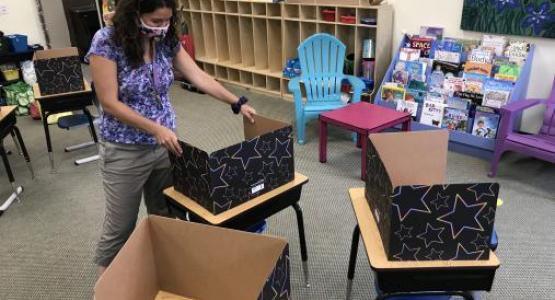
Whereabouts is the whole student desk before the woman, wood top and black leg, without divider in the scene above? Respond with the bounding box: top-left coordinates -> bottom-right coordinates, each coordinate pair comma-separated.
164,173 -> 310,287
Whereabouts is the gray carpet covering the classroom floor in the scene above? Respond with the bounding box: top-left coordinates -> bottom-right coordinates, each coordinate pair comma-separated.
0,87 -> 555,300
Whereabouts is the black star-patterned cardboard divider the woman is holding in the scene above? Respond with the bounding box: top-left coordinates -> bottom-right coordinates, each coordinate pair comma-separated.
170,115 -> 295,214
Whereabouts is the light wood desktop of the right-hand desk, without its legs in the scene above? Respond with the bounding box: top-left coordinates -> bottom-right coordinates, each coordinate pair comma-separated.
349,188 -> 500,271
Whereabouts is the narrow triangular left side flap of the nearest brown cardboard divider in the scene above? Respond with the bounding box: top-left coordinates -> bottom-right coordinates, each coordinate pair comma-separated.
95,219 -> 159,300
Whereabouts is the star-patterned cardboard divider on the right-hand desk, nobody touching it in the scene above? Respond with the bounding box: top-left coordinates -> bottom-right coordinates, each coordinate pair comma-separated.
366,130 -> 499,260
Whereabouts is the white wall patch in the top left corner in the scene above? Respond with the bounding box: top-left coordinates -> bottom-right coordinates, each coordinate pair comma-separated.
0,0 -> 45,45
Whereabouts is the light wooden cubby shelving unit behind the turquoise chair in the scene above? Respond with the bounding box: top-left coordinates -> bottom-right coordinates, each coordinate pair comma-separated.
179,0 -> 393,99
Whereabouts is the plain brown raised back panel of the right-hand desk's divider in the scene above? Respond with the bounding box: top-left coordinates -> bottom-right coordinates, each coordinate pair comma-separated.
370,130 -> 449,187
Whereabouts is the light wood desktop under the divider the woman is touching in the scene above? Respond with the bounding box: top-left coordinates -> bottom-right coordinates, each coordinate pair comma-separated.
164,173 -> 308,225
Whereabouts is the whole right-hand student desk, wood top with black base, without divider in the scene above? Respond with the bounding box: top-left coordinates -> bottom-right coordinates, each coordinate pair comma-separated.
347,188 -> 500,299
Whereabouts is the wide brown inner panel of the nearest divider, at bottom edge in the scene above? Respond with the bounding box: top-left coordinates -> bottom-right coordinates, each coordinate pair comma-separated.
149,216 -> 287,300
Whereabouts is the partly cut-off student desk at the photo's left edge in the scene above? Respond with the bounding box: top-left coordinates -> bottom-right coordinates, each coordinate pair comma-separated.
0,105 -> 35,215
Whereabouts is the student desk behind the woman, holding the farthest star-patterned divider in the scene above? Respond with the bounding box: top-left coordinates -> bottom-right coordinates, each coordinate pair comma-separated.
33,81 -> 98,171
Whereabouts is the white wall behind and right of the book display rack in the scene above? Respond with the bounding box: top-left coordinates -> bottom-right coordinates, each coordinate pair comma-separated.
388,0 -> 555,132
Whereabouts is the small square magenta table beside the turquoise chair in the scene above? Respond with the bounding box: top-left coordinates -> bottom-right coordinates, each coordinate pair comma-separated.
320,102 -> 412,180
